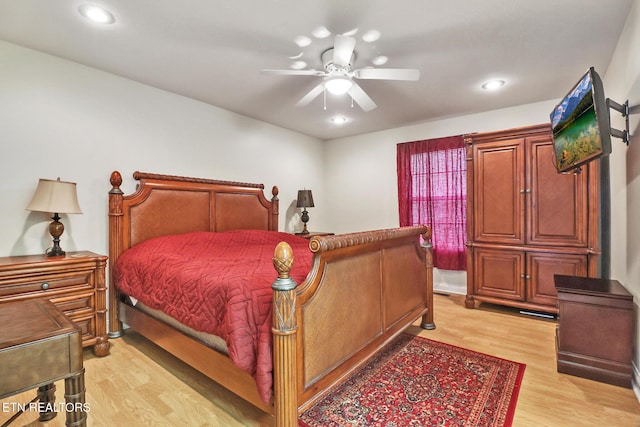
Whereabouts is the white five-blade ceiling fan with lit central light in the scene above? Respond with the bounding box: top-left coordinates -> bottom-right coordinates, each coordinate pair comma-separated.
262,34 -> 420,111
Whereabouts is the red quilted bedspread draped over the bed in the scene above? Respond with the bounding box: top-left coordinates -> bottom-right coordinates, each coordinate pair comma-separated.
114,230 -> 312,402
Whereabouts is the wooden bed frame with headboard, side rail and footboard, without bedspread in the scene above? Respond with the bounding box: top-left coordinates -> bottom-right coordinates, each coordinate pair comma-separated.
109,171 -> 435,426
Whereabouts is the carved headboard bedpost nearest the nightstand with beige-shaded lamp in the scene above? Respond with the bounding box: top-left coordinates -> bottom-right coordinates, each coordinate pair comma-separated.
107,171 -> 124,338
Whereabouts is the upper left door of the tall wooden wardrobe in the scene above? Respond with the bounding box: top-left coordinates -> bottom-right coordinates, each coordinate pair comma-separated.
473,138 -> 525,244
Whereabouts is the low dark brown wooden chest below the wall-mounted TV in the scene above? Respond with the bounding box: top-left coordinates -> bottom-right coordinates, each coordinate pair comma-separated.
554,275 -> 633,388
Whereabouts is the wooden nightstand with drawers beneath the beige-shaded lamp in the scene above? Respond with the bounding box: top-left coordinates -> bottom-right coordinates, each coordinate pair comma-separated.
0,251 -> 109,356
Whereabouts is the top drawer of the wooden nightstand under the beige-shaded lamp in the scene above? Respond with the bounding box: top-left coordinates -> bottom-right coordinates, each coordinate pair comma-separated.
0,271 -> 94,300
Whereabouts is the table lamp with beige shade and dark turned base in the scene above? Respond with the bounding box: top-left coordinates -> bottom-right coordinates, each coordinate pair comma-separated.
27,178 -> 82,256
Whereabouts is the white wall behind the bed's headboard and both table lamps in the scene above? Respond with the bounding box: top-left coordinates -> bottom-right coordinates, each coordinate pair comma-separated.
0,41 -> 328,256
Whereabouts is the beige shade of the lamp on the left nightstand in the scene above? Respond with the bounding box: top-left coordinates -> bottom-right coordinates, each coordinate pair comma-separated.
27,178 -> 82,214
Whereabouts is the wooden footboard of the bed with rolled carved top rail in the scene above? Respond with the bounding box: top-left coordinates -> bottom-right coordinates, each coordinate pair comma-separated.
273,227 -> 435,426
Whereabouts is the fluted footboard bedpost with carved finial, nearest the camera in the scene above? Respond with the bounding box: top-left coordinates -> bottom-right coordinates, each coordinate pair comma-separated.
271,242 -> 298,427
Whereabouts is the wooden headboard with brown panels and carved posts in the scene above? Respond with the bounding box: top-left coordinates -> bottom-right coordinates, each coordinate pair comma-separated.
109,171 -> 279,331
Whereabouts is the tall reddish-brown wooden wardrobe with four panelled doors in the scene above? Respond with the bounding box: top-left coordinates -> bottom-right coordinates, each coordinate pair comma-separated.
465,124 -> 600,313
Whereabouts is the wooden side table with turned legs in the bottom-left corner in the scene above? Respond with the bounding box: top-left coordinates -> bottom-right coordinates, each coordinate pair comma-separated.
0,299 -> 88,426
